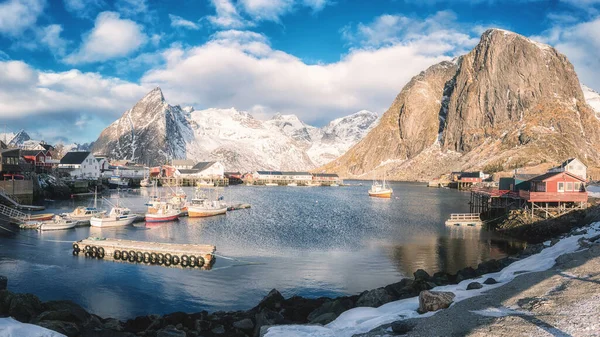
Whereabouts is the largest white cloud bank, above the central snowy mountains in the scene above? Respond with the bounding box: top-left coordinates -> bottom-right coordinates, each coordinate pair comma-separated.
142,25 -> 454,122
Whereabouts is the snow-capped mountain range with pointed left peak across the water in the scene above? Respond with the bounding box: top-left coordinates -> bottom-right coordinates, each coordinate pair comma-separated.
92,88 -> 377,171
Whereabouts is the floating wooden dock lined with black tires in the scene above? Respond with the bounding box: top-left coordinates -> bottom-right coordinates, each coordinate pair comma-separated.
73,237 -> 216,270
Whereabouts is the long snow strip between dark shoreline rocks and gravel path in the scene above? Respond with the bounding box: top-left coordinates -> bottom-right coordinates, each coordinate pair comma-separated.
265,222 -> 600,337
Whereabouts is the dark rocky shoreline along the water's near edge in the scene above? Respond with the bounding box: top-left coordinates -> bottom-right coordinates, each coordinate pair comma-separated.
0,239 -> 544,337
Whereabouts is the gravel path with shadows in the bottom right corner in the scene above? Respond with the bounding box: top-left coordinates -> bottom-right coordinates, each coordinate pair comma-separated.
400,244 -> 600,337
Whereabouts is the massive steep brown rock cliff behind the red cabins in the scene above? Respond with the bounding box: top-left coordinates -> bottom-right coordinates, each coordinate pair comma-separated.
322,29 -> 600,180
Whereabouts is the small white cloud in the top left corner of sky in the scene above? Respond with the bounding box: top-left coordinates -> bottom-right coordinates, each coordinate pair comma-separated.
0,0 -> 46,37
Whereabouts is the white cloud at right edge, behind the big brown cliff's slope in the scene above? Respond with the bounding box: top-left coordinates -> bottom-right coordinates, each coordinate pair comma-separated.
532,17 -> 600,91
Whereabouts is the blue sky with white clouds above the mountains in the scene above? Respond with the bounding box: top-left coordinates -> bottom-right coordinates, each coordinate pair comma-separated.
0,0 -> 600,143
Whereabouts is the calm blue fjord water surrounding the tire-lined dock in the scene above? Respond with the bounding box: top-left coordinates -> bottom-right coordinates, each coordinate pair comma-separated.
0,182 -> 522,319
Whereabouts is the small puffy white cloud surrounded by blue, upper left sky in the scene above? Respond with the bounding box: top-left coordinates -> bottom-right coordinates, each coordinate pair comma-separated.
65,12 -> 148,64
